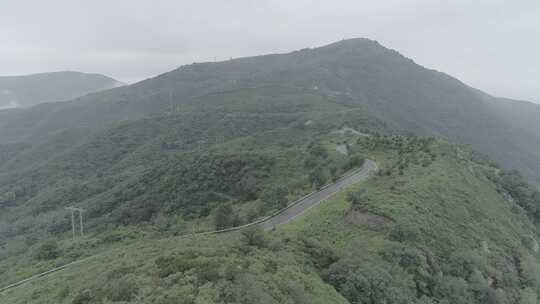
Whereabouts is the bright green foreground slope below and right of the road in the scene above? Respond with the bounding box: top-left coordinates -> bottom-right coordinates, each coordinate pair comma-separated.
0,135 -> 540,303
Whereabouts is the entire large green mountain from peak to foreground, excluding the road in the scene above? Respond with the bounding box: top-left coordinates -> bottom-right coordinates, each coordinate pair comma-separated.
0,39 -> 540,304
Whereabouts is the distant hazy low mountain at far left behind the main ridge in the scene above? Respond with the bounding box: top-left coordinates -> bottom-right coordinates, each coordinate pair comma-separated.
0,72 -> 124,110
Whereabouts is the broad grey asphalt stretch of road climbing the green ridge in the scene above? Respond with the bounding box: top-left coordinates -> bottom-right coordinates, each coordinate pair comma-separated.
259,159 -> 378,230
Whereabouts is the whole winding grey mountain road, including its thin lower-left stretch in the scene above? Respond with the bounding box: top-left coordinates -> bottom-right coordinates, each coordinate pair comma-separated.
0,159 -> 378,294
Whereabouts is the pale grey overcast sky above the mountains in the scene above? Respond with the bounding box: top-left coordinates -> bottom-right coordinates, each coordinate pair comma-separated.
0,0 -> 540,102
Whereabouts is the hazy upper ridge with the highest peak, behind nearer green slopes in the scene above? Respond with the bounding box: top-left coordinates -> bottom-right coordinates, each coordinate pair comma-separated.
0,39 -> 540,182
